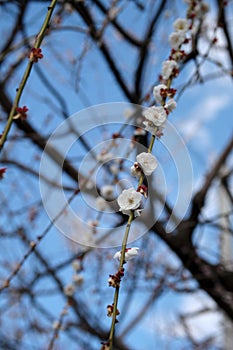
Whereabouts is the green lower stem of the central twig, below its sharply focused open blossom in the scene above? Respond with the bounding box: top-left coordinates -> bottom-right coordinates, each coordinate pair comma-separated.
109,211 -> 134,350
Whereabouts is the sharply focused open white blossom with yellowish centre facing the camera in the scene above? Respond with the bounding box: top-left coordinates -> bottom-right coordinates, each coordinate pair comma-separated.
117,187 -> 142,215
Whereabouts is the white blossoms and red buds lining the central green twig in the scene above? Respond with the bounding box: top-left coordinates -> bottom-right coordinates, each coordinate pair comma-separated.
101,0 -> 209,350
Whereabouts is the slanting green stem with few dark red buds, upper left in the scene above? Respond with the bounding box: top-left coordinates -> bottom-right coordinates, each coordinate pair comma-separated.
0,0 -> 57,152
